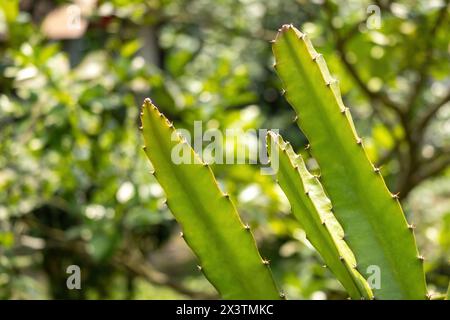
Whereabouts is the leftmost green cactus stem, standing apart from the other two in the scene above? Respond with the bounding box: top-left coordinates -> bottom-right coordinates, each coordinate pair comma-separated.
141,99 -> 280,299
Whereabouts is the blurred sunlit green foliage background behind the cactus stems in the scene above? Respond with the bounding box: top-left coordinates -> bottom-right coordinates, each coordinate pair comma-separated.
0,0 -> 450,299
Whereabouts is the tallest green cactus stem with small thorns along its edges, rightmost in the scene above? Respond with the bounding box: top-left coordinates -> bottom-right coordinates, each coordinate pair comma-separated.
273,25 -> 426,299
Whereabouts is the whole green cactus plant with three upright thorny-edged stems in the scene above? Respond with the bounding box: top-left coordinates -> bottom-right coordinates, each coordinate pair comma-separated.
141,25 -> 429,299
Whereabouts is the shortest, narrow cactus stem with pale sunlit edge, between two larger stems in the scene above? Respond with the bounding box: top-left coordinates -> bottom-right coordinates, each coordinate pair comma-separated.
267,132 -> 373,299
